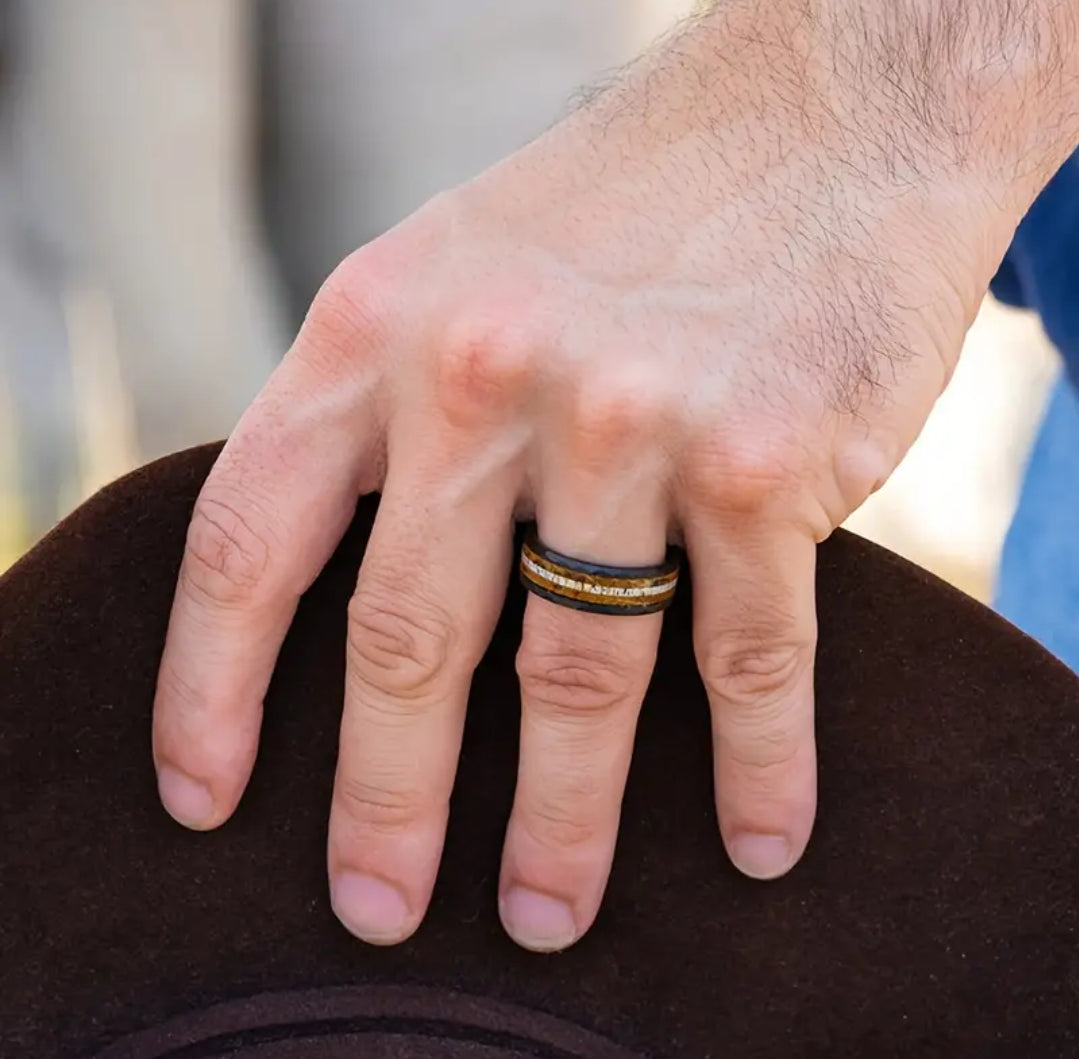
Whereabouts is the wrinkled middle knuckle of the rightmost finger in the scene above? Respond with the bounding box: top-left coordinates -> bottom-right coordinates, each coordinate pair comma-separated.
701,637 -> 812,712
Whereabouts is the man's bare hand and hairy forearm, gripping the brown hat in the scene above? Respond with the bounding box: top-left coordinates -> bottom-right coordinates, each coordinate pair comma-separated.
153,0 -> 1079,950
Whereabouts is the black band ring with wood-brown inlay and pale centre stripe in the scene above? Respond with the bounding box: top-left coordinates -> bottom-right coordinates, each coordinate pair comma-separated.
520,530 -> 679,614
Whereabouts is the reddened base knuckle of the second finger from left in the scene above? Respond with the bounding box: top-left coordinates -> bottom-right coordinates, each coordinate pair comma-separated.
435,310 -> 537,422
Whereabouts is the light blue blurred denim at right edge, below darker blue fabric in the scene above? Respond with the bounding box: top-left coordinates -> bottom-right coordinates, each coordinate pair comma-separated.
995,378 -> 1079,671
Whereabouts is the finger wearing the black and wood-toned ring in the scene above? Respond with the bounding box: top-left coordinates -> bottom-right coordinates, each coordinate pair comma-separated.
500,395 -> 667,951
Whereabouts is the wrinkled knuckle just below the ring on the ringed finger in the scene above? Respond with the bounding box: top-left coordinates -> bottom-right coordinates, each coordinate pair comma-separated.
517,642 -> 632,717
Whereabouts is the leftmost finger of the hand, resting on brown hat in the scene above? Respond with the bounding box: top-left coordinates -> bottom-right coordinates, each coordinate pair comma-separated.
153,278 -> 388,830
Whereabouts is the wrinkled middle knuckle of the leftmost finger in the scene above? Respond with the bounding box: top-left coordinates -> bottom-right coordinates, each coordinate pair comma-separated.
182,495 -> 272,603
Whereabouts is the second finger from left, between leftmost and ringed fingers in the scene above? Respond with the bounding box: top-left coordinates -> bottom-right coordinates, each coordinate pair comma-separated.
328,405 -> 518,945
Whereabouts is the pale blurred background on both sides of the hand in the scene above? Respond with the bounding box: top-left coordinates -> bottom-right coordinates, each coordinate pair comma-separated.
0,0 -> 1057,599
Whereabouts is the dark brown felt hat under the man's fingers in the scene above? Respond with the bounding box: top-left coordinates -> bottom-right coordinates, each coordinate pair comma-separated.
0,440 -> 1079,1059
